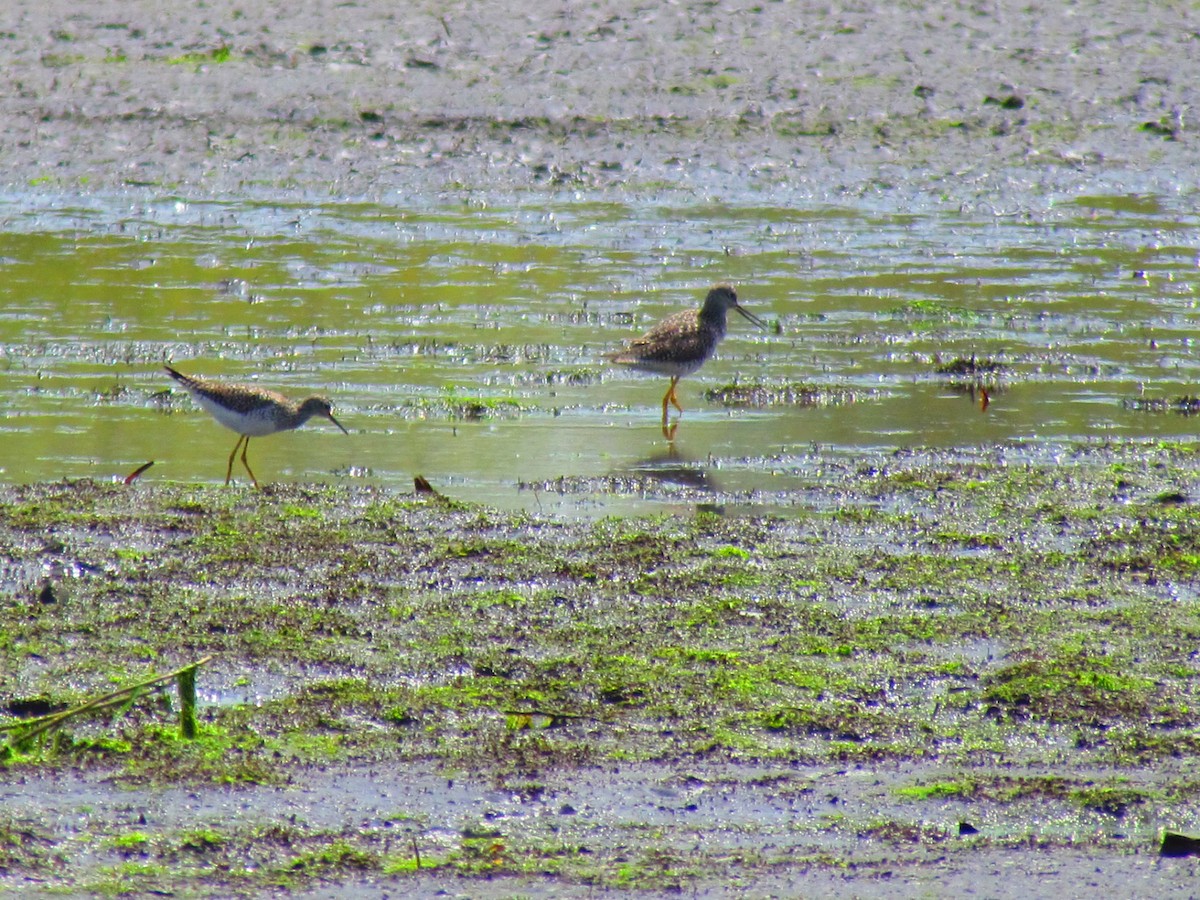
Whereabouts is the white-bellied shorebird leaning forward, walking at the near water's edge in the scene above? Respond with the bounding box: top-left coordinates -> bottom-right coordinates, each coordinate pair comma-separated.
163,366 -> 350,487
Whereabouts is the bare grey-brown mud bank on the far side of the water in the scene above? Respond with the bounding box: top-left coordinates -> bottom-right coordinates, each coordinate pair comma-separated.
0,0 -> 1200,200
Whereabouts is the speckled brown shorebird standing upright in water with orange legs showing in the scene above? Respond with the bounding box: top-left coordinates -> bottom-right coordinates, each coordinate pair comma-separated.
606,284 -> 767,428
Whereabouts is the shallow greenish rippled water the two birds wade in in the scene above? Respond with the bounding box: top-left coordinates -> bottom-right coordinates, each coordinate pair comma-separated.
0,193 -> 1200,515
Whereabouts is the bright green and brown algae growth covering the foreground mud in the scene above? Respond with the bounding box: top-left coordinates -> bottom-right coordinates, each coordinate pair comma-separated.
0,445 -> 1200,893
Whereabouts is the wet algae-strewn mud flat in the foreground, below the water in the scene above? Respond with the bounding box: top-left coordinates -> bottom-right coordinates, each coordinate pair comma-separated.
0,444 -> 1200,896
